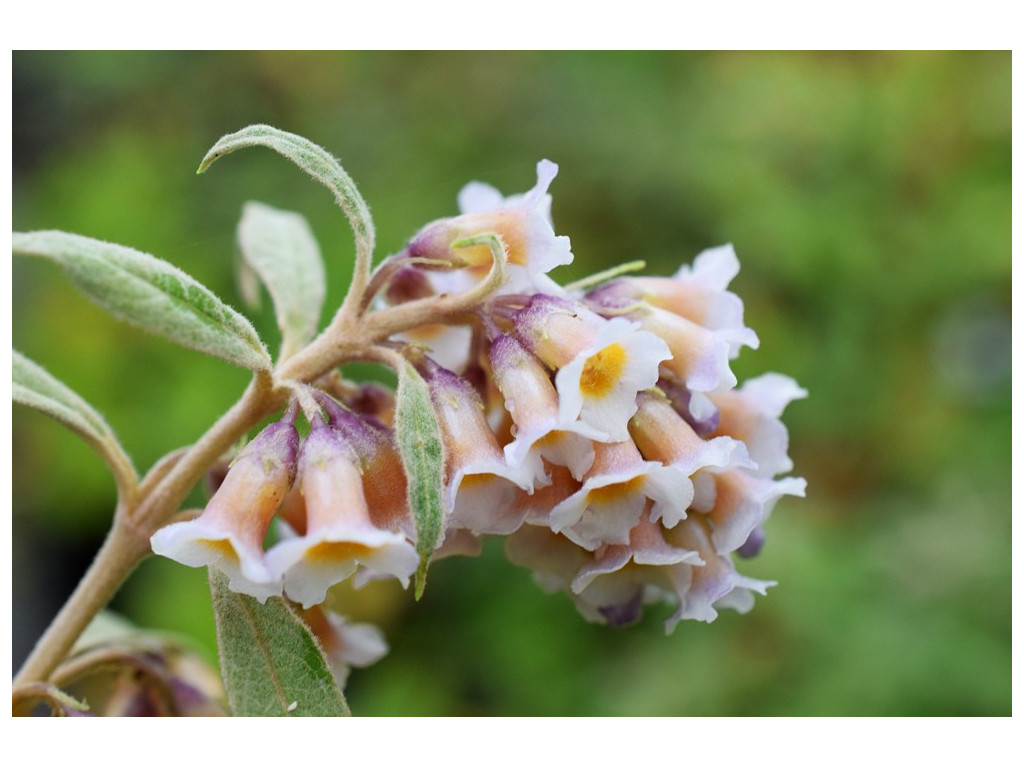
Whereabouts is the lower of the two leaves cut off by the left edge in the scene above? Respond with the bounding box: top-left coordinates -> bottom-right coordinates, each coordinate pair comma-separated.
11,349 -> 138,492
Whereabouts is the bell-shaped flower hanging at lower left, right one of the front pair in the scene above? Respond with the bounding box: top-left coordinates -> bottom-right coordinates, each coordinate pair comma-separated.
266,419 -> 419,608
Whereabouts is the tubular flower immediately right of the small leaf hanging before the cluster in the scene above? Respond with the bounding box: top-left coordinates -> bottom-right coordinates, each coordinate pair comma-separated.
426,366 -> 534,535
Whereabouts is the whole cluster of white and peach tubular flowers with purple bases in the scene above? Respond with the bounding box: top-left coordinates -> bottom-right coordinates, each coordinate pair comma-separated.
153,161 -> 806,662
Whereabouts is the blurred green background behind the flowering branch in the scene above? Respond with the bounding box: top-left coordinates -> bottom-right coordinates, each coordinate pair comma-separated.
12,52 -> 1011,715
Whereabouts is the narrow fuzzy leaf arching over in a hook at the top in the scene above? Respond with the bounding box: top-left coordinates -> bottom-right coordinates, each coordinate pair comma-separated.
197,125 -> 375,282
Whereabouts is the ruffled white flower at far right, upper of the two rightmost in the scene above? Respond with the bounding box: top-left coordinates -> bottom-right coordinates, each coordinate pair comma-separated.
711,374 -> 807,477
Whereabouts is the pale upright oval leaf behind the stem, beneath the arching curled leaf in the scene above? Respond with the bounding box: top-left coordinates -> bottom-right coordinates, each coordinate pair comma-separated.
238,202 -> 326,359
